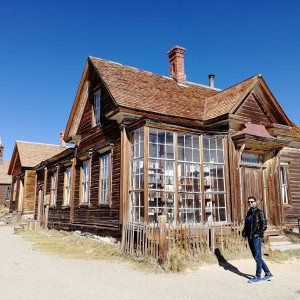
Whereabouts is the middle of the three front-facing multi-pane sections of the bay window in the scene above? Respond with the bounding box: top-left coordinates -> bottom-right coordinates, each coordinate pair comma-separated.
177,133 -> 202,223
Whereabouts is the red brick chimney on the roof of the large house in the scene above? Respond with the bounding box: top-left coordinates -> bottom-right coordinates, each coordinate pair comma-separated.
168,46 -> 186,83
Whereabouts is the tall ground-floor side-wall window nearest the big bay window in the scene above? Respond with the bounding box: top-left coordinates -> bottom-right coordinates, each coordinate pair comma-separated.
98,152 -> 112,206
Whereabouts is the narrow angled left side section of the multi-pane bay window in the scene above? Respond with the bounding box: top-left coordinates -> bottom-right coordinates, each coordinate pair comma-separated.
130,128 -> 144,222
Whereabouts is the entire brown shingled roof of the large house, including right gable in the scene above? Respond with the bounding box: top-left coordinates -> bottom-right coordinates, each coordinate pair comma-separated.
65,57 -> 292,140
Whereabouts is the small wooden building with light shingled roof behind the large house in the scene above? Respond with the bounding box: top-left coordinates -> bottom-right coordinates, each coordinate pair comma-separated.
8,141 -> 66,218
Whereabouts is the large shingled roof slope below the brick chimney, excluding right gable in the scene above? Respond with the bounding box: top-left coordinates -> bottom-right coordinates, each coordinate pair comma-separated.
89,57 -> 219,120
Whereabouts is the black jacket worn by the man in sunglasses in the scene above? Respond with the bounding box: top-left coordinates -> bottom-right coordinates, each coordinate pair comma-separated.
242,207 -> 267,239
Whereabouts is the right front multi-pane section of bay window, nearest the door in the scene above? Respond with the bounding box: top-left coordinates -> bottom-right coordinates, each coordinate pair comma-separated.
203,136 -> 227,222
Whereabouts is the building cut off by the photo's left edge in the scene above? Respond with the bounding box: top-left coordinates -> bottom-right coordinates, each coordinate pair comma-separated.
0,138 -> 11,208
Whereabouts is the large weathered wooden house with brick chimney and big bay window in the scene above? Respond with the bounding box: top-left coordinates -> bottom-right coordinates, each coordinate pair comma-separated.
29,46 -> 300,235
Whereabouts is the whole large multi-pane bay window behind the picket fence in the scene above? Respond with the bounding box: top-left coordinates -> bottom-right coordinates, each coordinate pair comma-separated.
130,128 -> 227,223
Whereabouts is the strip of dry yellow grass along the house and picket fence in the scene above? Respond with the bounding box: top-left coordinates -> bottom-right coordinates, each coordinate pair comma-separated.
22,230 -> 300,273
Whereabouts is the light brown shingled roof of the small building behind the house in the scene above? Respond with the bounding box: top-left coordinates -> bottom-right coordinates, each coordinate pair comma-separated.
8,141 -> 66,174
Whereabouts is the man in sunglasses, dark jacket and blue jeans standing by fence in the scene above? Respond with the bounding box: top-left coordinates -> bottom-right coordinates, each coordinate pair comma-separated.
242,196 -> 273,283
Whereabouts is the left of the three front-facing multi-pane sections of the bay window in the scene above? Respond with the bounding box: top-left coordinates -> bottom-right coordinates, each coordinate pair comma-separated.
148,128 -> 175,222
